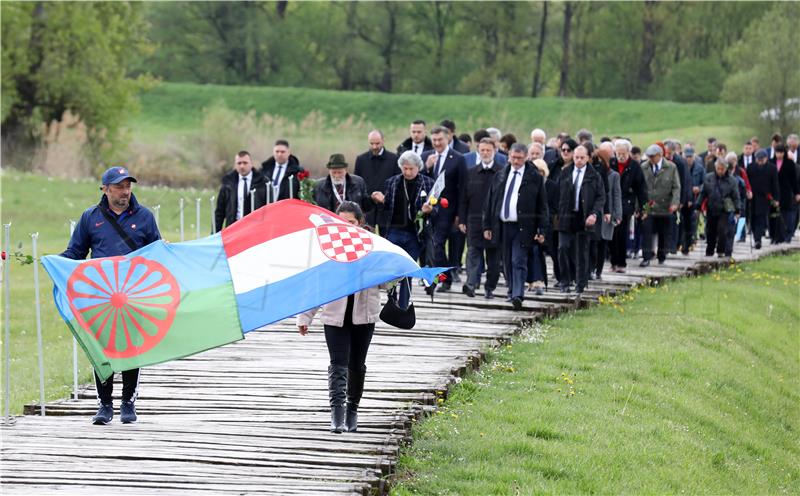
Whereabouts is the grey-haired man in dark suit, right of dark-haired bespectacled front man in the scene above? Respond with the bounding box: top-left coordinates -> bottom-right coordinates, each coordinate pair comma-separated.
557,145 -> 606,293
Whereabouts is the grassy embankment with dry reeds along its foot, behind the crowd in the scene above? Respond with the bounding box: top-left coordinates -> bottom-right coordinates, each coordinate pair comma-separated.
129,83 -> 751,183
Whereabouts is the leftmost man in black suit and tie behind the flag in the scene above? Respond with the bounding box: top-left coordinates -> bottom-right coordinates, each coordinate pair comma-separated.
214,151 -> 267,232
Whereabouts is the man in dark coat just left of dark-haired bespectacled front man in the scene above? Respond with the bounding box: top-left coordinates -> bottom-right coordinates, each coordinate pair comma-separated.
458,136 -> 503,300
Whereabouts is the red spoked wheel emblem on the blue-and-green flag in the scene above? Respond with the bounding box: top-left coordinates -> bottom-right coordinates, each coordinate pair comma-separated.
67,257 -> 181,358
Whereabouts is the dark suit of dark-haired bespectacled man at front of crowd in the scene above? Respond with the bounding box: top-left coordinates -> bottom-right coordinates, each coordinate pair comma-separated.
483,166 -> 550,300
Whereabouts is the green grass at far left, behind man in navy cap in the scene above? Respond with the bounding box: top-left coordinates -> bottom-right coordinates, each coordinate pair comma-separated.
0,170 -> 212,414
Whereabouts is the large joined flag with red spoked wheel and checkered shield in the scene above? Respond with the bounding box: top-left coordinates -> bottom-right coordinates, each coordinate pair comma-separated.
42,200 -> 444,379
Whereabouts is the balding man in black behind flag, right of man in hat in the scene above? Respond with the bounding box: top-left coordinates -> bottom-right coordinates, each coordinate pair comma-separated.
354,129 -> 400,228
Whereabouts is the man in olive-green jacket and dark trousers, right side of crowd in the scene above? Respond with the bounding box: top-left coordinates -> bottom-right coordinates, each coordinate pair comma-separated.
639,145 -> 681,267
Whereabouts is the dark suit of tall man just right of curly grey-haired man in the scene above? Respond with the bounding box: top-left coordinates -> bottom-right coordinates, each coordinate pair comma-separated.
421,148 -> 467,287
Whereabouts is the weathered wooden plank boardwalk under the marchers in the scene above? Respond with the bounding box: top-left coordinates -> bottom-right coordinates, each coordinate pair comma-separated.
0,240 -> 800,495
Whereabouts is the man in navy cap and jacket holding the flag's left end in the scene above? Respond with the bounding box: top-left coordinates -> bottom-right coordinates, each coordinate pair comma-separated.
61,166 -> 161,425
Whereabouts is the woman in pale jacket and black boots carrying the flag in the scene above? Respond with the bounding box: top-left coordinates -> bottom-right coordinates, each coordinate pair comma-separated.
297,201 -> 380,434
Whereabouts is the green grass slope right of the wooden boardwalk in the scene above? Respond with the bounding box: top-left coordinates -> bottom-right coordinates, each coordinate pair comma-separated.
393,254 -> 800,495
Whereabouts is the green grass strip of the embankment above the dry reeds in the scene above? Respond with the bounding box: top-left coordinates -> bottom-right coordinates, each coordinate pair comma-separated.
131,83 -> 748,144
